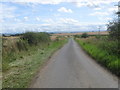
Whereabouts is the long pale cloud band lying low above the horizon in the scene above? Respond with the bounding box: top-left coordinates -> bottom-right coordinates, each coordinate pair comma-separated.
2,18 -> 105,33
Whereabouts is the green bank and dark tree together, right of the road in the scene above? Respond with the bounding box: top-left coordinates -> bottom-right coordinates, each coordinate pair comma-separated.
75,21 -> 120,77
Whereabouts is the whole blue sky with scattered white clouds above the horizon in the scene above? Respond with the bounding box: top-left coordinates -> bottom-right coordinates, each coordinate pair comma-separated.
0,0 -> 119,33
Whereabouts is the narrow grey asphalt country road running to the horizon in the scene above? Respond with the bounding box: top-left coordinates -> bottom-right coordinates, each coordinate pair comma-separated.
30,39 -> 118,88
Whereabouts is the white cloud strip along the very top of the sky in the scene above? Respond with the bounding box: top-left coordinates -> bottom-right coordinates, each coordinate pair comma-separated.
0,0 -> 119,8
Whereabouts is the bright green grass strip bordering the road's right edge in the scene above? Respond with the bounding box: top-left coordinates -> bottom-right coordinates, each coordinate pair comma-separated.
76,39 -> 120,76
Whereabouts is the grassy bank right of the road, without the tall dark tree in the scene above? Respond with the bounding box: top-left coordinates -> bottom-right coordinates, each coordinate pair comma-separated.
76,36 -> 120,76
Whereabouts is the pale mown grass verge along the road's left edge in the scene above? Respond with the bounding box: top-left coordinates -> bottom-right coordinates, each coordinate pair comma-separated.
3,40 -> 67,88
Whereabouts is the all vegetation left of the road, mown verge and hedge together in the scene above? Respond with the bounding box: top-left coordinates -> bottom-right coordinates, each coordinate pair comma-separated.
2,32 -> 67,88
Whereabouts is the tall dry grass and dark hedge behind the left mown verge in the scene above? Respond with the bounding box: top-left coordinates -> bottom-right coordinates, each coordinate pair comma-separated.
2,32 -> 50,71
